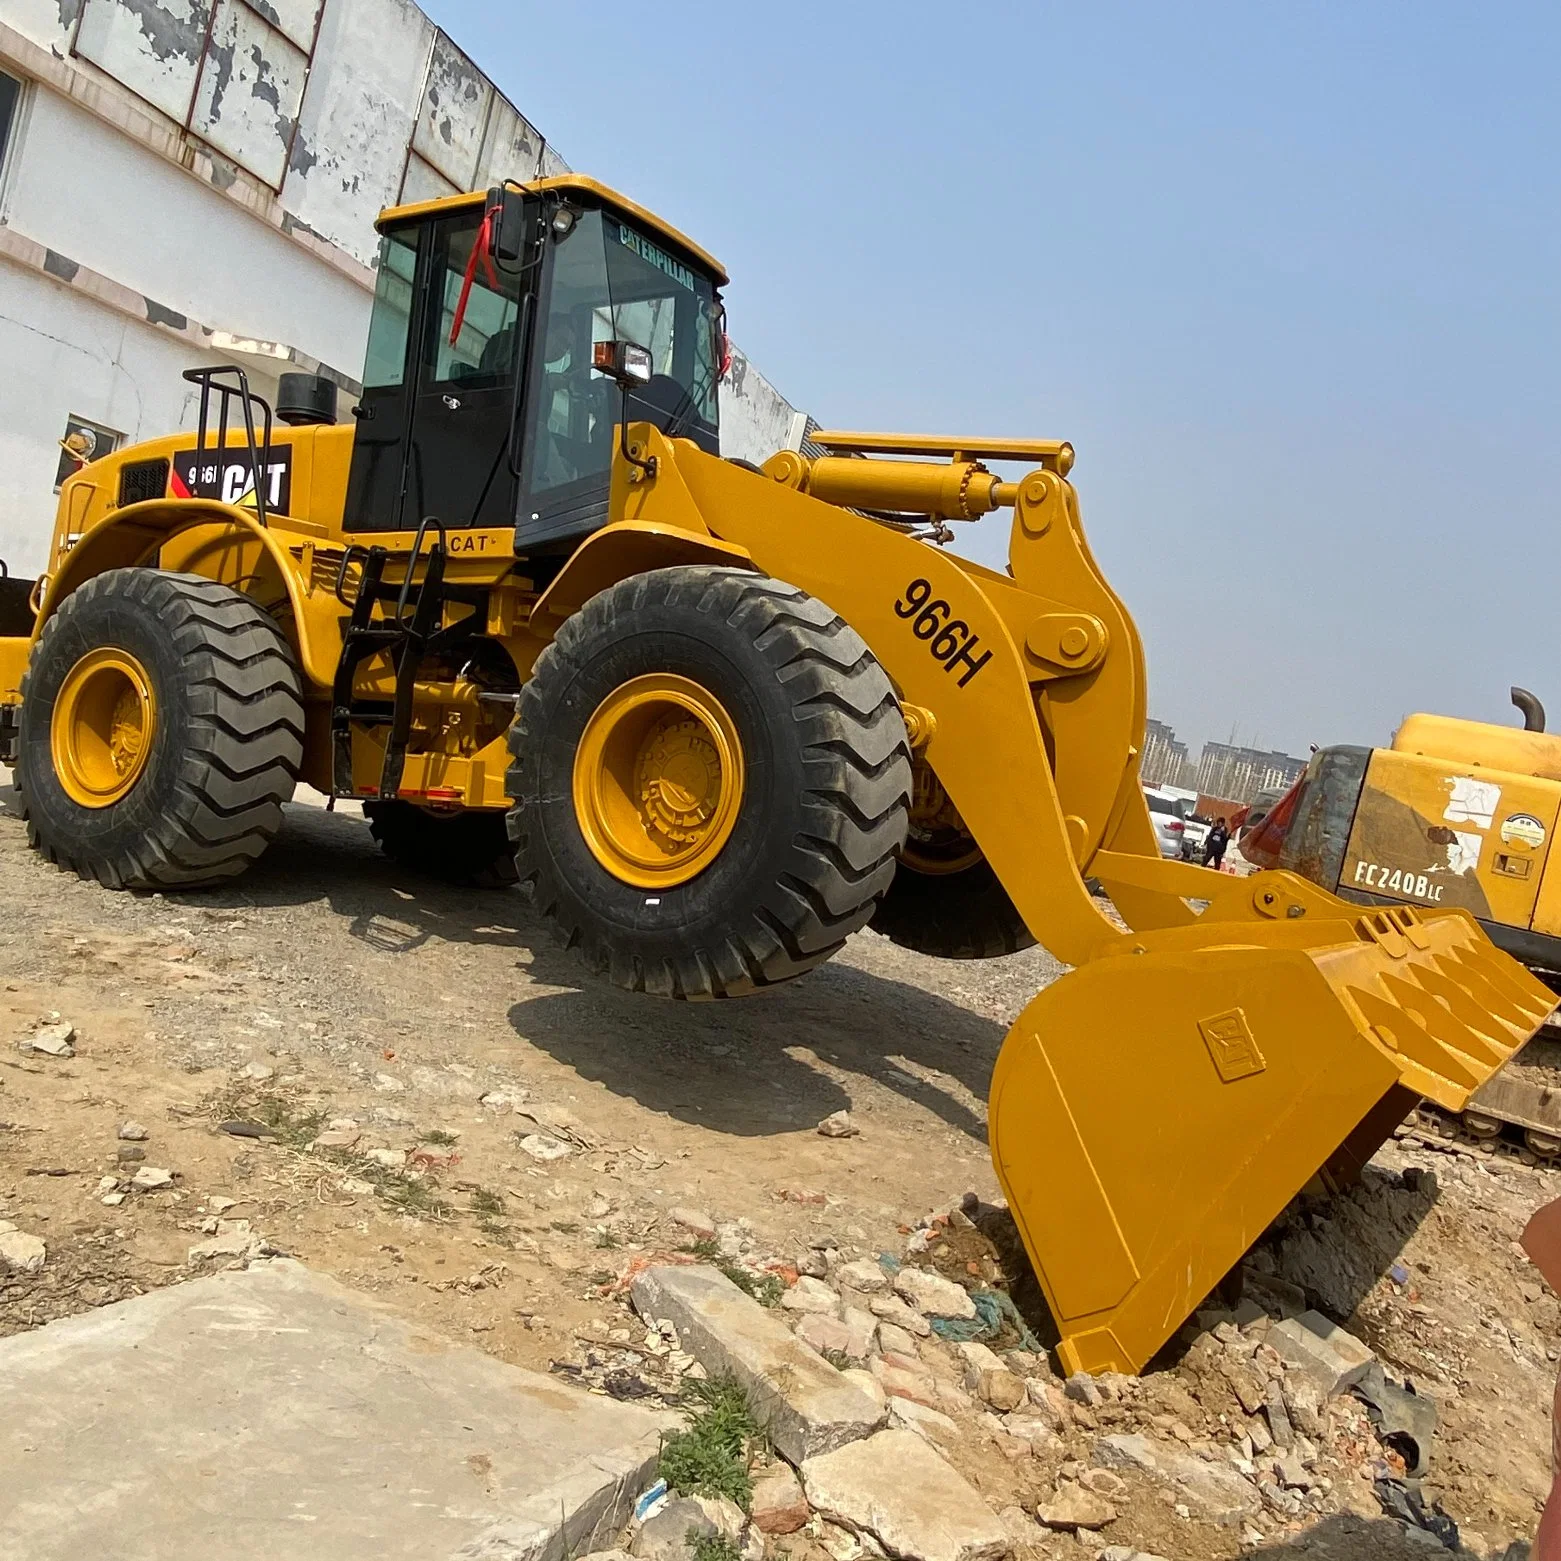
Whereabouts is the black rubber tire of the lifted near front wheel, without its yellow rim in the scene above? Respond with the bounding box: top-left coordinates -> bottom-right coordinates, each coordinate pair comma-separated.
509,567 -> 910,997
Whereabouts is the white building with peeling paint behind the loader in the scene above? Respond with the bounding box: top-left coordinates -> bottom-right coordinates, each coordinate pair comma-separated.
0,0 -> 802,574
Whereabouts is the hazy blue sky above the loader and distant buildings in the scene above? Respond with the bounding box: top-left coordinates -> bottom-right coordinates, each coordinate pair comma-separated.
425,0 -> 1561,752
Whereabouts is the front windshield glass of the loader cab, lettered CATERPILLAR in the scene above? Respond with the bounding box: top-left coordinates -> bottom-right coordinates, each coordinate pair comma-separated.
528,211 -> 720,495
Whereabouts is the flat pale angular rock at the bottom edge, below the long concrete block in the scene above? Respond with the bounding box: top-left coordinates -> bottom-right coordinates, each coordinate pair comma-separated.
802,1431 -> 1010,1561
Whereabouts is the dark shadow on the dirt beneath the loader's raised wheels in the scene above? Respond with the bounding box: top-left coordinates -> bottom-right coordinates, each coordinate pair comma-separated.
0,790 -> 1004,1146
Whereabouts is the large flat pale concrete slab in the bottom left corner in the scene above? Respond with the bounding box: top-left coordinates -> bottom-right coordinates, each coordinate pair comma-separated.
0,1260 -> 664,1561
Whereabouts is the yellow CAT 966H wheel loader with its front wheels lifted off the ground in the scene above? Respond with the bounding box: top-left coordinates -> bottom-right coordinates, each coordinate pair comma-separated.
0,176 -> 1550,1371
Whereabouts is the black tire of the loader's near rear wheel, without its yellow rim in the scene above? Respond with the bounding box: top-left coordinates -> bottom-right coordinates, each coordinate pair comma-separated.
16,570 -> 303,890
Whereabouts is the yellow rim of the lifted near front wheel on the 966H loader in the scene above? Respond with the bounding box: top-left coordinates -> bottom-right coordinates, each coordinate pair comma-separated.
574,673 -> 743,888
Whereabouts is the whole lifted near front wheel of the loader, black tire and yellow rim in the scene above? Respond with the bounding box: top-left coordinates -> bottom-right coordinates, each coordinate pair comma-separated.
509,567 -> 910,997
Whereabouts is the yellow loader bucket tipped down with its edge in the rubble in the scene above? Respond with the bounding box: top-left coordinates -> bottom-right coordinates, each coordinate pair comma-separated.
990,904 -> 1555,1372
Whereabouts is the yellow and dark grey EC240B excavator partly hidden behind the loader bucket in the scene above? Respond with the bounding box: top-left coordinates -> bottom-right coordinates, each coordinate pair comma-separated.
1241,688 -> 1561,1160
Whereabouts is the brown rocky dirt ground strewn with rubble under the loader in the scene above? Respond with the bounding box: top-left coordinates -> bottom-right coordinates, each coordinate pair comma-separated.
0,771 -> 1561,1561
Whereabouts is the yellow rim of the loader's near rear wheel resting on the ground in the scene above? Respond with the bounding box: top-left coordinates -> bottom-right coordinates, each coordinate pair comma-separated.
48,646 -> 158,807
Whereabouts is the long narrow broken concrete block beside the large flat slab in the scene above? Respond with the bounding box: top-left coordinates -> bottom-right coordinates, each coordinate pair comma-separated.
632,1264 -> 884,1464
